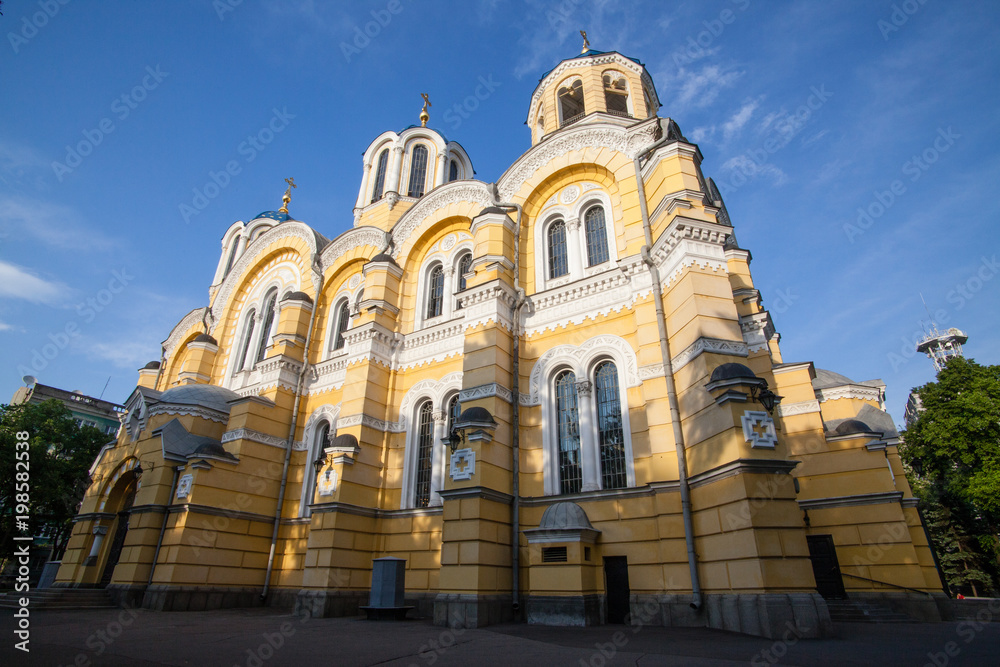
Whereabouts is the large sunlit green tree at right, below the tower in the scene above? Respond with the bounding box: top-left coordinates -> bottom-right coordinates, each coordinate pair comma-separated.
900,357 -> 1000,593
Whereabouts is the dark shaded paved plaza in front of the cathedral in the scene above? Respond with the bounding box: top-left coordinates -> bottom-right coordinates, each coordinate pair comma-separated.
0,609 -> 1000,667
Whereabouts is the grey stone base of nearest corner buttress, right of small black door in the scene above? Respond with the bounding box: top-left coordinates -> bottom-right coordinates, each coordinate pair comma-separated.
630,593 -> 833,639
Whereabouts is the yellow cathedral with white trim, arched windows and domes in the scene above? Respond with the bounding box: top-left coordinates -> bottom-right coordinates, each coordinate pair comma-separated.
56,45 -> 945,637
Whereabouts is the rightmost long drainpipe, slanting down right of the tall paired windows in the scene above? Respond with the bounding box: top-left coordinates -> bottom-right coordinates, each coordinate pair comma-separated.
633,124 -> 702,609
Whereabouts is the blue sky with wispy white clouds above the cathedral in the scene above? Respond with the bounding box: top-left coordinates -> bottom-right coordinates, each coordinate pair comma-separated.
0,0 -> 1000,422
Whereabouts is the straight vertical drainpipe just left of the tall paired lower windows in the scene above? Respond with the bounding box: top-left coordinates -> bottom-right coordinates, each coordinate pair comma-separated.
494,198 -> 527,614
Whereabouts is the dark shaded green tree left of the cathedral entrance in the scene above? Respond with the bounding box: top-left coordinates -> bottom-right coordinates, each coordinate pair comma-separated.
0,400 -> 108,572
